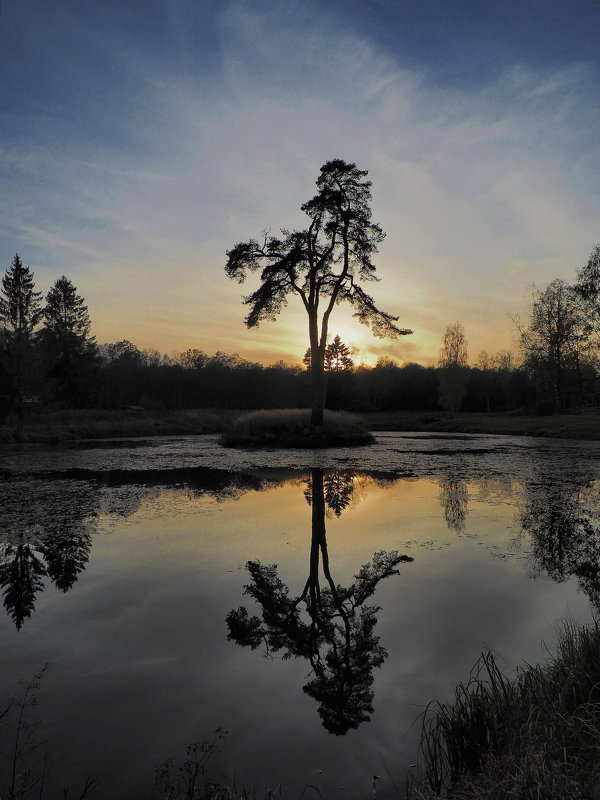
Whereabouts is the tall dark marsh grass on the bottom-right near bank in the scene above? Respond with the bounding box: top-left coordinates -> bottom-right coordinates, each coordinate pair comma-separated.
408,623 -> 600,800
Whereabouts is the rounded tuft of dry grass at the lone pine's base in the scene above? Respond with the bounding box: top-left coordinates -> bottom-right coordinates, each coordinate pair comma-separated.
220,408 -> 375,449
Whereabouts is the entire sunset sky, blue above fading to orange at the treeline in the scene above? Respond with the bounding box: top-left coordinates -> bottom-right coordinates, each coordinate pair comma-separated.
0,0 -> 600,363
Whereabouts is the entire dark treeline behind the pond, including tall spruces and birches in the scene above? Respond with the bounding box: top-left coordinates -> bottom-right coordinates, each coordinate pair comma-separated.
0,247 -> 600,419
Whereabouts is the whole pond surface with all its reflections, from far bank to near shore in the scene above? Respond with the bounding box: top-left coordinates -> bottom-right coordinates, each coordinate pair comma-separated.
0,433 -> 600,800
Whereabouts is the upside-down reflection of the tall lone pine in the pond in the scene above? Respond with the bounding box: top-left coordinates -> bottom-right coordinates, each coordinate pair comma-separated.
227,469 -> 413,734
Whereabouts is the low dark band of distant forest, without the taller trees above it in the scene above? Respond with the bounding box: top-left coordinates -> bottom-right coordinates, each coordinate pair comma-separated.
0,330 -> 576,412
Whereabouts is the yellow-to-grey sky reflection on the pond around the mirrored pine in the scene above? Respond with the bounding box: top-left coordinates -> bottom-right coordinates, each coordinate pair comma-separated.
0,468 -> 589,800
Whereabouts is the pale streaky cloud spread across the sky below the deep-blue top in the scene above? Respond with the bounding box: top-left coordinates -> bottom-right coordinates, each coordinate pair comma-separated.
0,2 -> 600,360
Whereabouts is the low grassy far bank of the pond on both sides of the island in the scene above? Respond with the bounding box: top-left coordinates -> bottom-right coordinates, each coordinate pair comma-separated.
0,409 -> 600,446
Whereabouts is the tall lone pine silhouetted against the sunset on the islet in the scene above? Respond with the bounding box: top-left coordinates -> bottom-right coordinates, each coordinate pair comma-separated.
225,158 -> 412,425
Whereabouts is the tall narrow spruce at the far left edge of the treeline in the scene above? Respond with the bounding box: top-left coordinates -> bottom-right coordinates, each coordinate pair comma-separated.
0,253 -> 41,424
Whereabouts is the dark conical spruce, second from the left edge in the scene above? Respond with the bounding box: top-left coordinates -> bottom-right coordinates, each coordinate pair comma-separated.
39,275 -> 97,408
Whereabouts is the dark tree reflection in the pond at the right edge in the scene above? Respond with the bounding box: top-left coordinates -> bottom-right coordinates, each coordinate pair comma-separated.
521,480 -> 600,611
